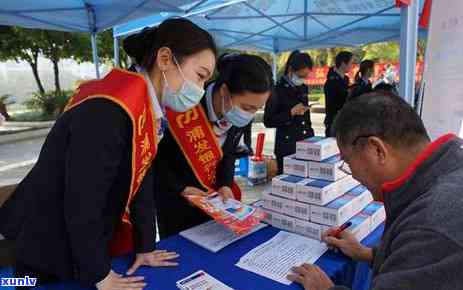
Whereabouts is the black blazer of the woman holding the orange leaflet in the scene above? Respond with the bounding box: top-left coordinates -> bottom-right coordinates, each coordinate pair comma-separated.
154,89 -> 246,195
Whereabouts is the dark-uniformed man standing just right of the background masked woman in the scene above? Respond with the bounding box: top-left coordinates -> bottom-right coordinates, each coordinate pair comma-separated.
323,51 -> 353,137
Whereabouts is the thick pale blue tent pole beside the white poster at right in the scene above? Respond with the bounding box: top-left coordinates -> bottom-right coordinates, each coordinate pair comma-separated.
399,0 -> 419,106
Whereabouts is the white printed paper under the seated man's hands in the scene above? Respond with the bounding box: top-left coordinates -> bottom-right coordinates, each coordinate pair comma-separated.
236,232 -> 328,285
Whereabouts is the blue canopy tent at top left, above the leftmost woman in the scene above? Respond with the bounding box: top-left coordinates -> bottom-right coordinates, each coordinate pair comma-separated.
0,0 -> 221,77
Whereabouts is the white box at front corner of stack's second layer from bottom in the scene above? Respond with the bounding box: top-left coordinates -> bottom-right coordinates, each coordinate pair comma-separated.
310,194 -> 355,226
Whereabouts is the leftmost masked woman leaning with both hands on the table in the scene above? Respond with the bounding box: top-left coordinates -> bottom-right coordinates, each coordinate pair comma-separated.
0,19 -> 216,290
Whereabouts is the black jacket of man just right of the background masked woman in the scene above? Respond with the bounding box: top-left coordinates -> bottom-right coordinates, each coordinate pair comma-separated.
323,68 -> 349,135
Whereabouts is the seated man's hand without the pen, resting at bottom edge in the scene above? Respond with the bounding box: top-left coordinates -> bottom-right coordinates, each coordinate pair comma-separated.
288,264 -> 334,290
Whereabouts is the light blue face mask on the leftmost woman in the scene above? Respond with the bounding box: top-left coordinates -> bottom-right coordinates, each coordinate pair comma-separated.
162,57 -> 204,112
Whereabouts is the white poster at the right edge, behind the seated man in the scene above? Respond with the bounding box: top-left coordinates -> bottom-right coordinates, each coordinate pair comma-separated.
421,0 -> 463,140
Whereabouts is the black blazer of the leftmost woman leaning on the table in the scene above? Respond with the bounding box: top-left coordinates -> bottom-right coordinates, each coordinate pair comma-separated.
0,99 -> 155,285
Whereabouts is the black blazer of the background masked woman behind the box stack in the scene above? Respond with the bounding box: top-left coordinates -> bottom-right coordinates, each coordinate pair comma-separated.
264,76 -> 314,156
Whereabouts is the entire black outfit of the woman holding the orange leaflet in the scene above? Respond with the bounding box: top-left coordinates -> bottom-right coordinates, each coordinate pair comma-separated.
154,90 -> 246,239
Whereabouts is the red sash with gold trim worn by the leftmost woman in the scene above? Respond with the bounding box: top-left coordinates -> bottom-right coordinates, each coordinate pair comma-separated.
65,69 -> 157,256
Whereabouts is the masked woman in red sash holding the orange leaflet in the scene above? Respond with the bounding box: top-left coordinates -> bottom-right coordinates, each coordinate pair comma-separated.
155,54 -> 272,239
